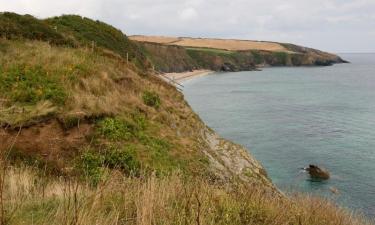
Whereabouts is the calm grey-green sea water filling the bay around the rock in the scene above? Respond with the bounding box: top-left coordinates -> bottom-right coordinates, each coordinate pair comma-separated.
184,54 -> 375,218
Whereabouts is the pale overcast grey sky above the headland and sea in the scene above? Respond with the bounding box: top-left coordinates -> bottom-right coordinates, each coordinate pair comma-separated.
0,0 -> 375,53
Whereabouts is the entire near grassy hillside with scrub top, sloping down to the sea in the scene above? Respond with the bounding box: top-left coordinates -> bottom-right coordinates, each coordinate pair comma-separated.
0,13 -> 365,225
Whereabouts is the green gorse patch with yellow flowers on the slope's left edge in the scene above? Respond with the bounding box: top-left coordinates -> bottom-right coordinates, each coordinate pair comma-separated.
0,64 -> 67,105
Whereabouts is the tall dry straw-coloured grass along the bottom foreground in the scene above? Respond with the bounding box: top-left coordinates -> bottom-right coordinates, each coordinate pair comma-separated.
0,167 -> 369,225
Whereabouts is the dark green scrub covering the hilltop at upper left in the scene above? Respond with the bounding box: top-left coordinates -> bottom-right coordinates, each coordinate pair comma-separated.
0,12 -> 148,70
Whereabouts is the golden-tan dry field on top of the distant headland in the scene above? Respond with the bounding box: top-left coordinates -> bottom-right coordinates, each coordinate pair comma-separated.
129,36 -> 289,52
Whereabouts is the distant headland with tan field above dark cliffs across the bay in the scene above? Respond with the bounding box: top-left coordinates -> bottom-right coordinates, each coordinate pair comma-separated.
129,35 -> 346,72
